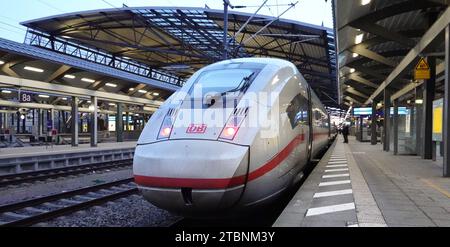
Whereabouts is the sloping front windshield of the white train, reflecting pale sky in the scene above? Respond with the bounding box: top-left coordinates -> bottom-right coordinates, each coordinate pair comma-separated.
191,69 -> 255,98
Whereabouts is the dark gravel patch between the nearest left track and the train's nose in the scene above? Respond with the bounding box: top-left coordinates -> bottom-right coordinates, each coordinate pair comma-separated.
35,195 -> 177,227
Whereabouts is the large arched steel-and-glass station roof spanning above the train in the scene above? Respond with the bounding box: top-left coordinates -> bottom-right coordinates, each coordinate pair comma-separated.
22,7 -> 338,106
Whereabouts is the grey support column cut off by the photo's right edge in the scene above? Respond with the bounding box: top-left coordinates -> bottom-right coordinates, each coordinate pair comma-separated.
442,26 -> 450,177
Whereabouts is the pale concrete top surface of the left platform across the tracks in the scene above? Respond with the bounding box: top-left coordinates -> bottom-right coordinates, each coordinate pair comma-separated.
0,141 -> 136,159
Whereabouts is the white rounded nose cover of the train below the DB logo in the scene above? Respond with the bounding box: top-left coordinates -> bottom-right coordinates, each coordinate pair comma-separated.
133,140 -> 249,214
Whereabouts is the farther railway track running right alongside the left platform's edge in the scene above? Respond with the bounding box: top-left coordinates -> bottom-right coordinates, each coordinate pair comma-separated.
0,159 -> 133,187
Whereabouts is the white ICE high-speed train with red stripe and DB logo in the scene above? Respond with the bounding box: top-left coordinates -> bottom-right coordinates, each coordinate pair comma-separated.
133,58 -> 330,215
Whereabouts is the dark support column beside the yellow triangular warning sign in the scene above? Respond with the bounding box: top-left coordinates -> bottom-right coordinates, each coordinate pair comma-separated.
422,57 -> 436,159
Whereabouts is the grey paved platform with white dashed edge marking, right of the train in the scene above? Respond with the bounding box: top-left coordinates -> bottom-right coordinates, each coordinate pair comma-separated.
274,136 -> 450,227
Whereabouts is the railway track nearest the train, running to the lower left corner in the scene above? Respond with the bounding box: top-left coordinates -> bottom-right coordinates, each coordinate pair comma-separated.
0,178 -> 138,226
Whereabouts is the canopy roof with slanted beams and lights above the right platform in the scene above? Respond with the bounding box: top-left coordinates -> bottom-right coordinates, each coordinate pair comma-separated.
334,0 -> 448,106
